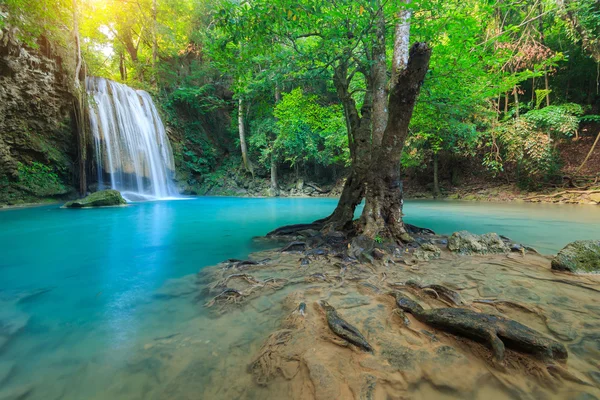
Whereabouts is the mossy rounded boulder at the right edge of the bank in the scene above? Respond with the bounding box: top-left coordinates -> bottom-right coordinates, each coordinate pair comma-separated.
552,240 -> 600,272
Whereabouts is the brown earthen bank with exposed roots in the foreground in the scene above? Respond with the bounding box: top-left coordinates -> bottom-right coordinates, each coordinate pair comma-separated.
150,235 -> 600,399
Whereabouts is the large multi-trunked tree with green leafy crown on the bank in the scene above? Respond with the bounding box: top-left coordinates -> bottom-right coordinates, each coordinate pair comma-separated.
217,0 -> 431,240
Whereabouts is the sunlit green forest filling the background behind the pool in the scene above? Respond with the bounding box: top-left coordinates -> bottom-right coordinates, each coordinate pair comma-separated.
0,0 -> 600,206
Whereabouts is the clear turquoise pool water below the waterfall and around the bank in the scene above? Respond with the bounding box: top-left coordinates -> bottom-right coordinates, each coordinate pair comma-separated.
0,198 -> 600,399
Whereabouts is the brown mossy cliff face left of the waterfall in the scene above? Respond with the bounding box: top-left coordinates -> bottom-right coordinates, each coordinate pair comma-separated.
0,27 -> 77,204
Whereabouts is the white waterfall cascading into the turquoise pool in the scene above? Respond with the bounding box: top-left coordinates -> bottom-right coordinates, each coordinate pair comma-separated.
86,77 -> 178,201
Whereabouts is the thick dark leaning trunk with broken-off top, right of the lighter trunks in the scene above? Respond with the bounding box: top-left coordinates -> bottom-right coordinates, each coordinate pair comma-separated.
360,43 -> 431,240
